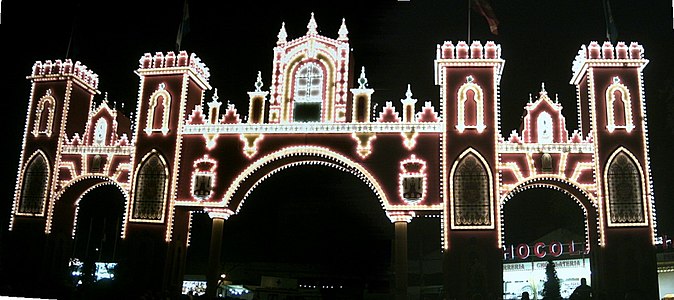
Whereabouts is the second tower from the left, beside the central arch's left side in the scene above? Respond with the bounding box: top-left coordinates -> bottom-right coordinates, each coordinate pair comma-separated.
123,51 -> 211,290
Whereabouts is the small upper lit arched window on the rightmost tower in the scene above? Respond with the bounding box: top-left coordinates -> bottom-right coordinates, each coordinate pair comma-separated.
606,77 -> 634,132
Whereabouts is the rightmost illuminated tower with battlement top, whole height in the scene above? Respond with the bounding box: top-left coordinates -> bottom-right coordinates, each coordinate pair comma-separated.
571,42 -> 658,298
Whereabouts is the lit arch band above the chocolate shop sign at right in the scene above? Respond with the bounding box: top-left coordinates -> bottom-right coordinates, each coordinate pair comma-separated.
498,176 -> 603,253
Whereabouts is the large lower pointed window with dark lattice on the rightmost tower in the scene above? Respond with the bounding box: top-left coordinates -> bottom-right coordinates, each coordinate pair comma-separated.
606,151 -> 645,223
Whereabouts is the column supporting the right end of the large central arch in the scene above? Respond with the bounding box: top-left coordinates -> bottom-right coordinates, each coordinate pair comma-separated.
386,211 -> 414,300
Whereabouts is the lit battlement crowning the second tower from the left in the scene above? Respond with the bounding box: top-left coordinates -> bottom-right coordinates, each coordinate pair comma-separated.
138,51 -> 211,83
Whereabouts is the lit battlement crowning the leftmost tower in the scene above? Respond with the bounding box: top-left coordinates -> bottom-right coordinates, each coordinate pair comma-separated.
28,59 -> 98,89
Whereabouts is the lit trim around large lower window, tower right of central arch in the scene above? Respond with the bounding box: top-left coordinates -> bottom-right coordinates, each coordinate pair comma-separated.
444,148 -> 495,230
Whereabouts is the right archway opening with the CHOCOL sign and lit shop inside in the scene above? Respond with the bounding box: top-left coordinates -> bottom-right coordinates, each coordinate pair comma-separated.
502,184 -> 596,299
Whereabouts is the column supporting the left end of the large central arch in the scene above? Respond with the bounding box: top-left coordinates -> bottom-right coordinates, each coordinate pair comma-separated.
204,208 -> 234,299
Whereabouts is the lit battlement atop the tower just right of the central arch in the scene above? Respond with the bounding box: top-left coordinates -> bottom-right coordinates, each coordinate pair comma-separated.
437,41 -> 501,59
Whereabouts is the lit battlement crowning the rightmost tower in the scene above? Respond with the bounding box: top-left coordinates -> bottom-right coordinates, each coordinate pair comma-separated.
571,41 -> 648,84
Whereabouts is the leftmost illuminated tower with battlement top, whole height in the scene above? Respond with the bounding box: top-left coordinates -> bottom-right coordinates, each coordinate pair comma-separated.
10,59 -> 99,284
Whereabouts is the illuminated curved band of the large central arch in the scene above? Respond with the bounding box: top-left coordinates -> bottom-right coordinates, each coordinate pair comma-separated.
220,146 -> 391,213
